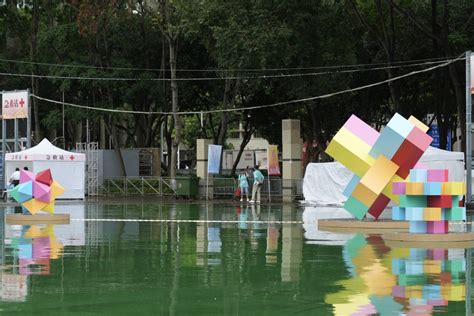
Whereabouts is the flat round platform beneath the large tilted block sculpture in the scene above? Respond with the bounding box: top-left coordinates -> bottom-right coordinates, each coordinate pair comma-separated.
318,218 -> 409,234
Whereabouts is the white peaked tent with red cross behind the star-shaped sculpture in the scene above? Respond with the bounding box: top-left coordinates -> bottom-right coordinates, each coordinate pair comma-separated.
5,138 -> 86,199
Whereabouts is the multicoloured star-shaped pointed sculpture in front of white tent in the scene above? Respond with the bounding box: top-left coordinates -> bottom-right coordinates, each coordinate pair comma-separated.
8,169 -> 65,215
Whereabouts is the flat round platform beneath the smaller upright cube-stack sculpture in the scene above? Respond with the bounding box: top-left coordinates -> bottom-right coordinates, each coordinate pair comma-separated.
383,232 -> 474,248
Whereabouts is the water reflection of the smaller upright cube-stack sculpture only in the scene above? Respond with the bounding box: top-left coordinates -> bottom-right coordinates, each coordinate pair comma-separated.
392,248 -> 464,314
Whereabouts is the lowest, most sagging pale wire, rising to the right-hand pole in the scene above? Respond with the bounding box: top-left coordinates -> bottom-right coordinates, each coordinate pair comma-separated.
31,55 -> 464,115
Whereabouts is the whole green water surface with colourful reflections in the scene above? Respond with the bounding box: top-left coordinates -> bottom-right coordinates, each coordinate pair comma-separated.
0,202 -> 470,315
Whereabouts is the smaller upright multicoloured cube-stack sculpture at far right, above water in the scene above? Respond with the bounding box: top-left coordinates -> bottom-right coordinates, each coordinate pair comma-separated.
392,169 -> 466,234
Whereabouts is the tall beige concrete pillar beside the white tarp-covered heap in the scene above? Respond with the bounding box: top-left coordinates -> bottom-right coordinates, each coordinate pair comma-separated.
281,120 -> 302,202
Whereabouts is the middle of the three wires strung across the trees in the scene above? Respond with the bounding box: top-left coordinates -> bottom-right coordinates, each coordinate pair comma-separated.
0,57 -> 465,81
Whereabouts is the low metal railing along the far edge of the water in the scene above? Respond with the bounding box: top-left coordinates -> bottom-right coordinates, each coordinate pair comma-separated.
99,177 -> 303,201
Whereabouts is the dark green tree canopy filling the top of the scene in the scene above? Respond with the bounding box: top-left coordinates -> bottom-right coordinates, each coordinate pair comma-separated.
0,0 -> 474,173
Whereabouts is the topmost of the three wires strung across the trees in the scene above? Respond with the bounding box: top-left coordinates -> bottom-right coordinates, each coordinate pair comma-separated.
0,57 -> 460,72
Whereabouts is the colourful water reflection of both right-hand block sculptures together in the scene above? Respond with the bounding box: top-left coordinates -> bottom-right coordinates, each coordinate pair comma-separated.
325,234 -> 466,315
